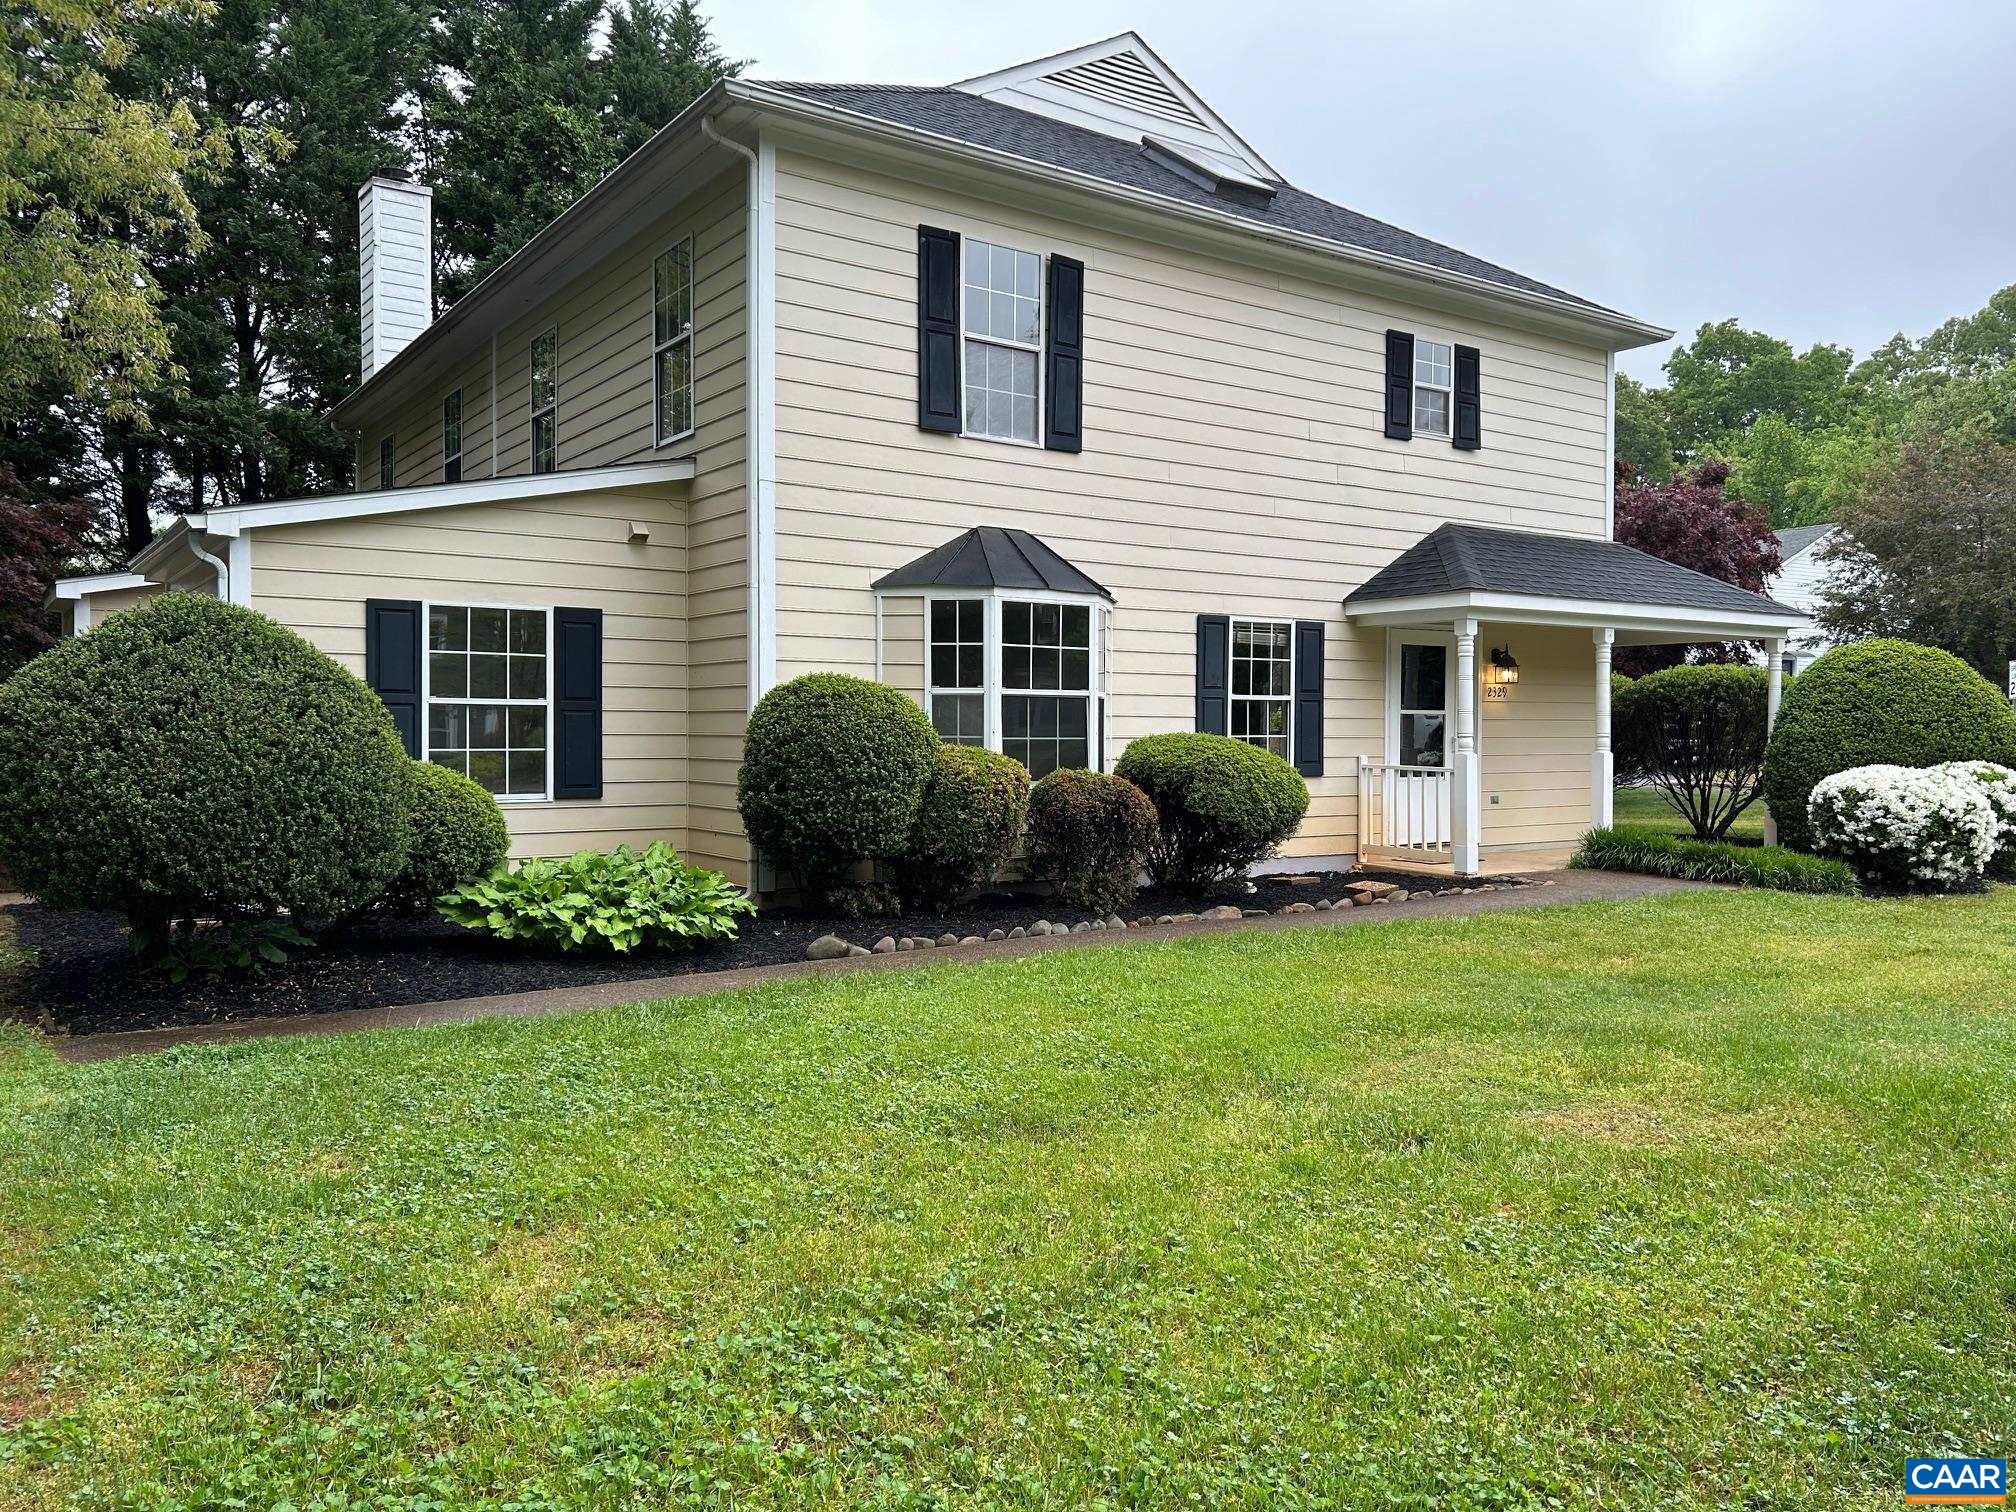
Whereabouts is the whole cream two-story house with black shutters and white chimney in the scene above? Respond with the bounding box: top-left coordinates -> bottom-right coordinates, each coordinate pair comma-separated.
58,32 -> 1800,885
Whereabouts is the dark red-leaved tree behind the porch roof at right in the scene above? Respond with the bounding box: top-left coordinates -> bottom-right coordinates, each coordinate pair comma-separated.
1615,458 -> 1780,677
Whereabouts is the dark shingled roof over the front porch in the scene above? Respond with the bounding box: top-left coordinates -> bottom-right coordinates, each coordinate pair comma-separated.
1345,524 -> 1798,615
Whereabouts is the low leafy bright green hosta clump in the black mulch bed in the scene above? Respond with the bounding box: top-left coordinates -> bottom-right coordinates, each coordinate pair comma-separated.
439,841 -> 756,952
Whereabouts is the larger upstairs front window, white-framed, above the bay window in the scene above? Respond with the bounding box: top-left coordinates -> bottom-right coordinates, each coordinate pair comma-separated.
960,236 -> 1042,446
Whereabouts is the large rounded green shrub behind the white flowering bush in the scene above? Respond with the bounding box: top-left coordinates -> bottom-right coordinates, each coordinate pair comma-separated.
1764,639 -> 2016,851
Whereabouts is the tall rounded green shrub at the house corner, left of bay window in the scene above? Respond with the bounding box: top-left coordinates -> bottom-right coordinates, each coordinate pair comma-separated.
736,671 -> 937,903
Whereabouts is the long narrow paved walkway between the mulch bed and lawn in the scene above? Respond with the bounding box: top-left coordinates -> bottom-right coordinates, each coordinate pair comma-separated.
50,871 -> 1706,1060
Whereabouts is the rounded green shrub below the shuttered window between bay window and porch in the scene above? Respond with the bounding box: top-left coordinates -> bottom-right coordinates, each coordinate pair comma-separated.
1113,734 -> 1308,895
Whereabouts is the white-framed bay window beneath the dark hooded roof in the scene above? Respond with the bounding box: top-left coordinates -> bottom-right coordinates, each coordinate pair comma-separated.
923,591 -> 1107,778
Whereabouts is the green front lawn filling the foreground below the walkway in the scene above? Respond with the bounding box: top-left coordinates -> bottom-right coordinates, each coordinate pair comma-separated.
0,889 -> 2016,1508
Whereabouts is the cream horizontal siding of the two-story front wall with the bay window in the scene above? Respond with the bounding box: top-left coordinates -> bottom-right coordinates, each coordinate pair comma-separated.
776,151 -> 1609,855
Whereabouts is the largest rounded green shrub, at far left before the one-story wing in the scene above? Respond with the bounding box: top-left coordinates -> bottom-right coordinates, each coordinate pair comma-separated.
0,593 -> 409,933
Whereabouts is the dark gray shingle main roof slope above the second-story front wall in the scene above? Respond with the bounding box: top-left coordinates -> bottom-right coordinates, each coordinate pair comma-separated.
750,79 -> 1617,314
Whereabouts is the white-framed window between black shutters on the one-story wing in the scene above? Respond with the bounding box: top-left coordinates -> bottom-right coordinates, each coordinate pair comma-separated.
419,603 -> 552,802
